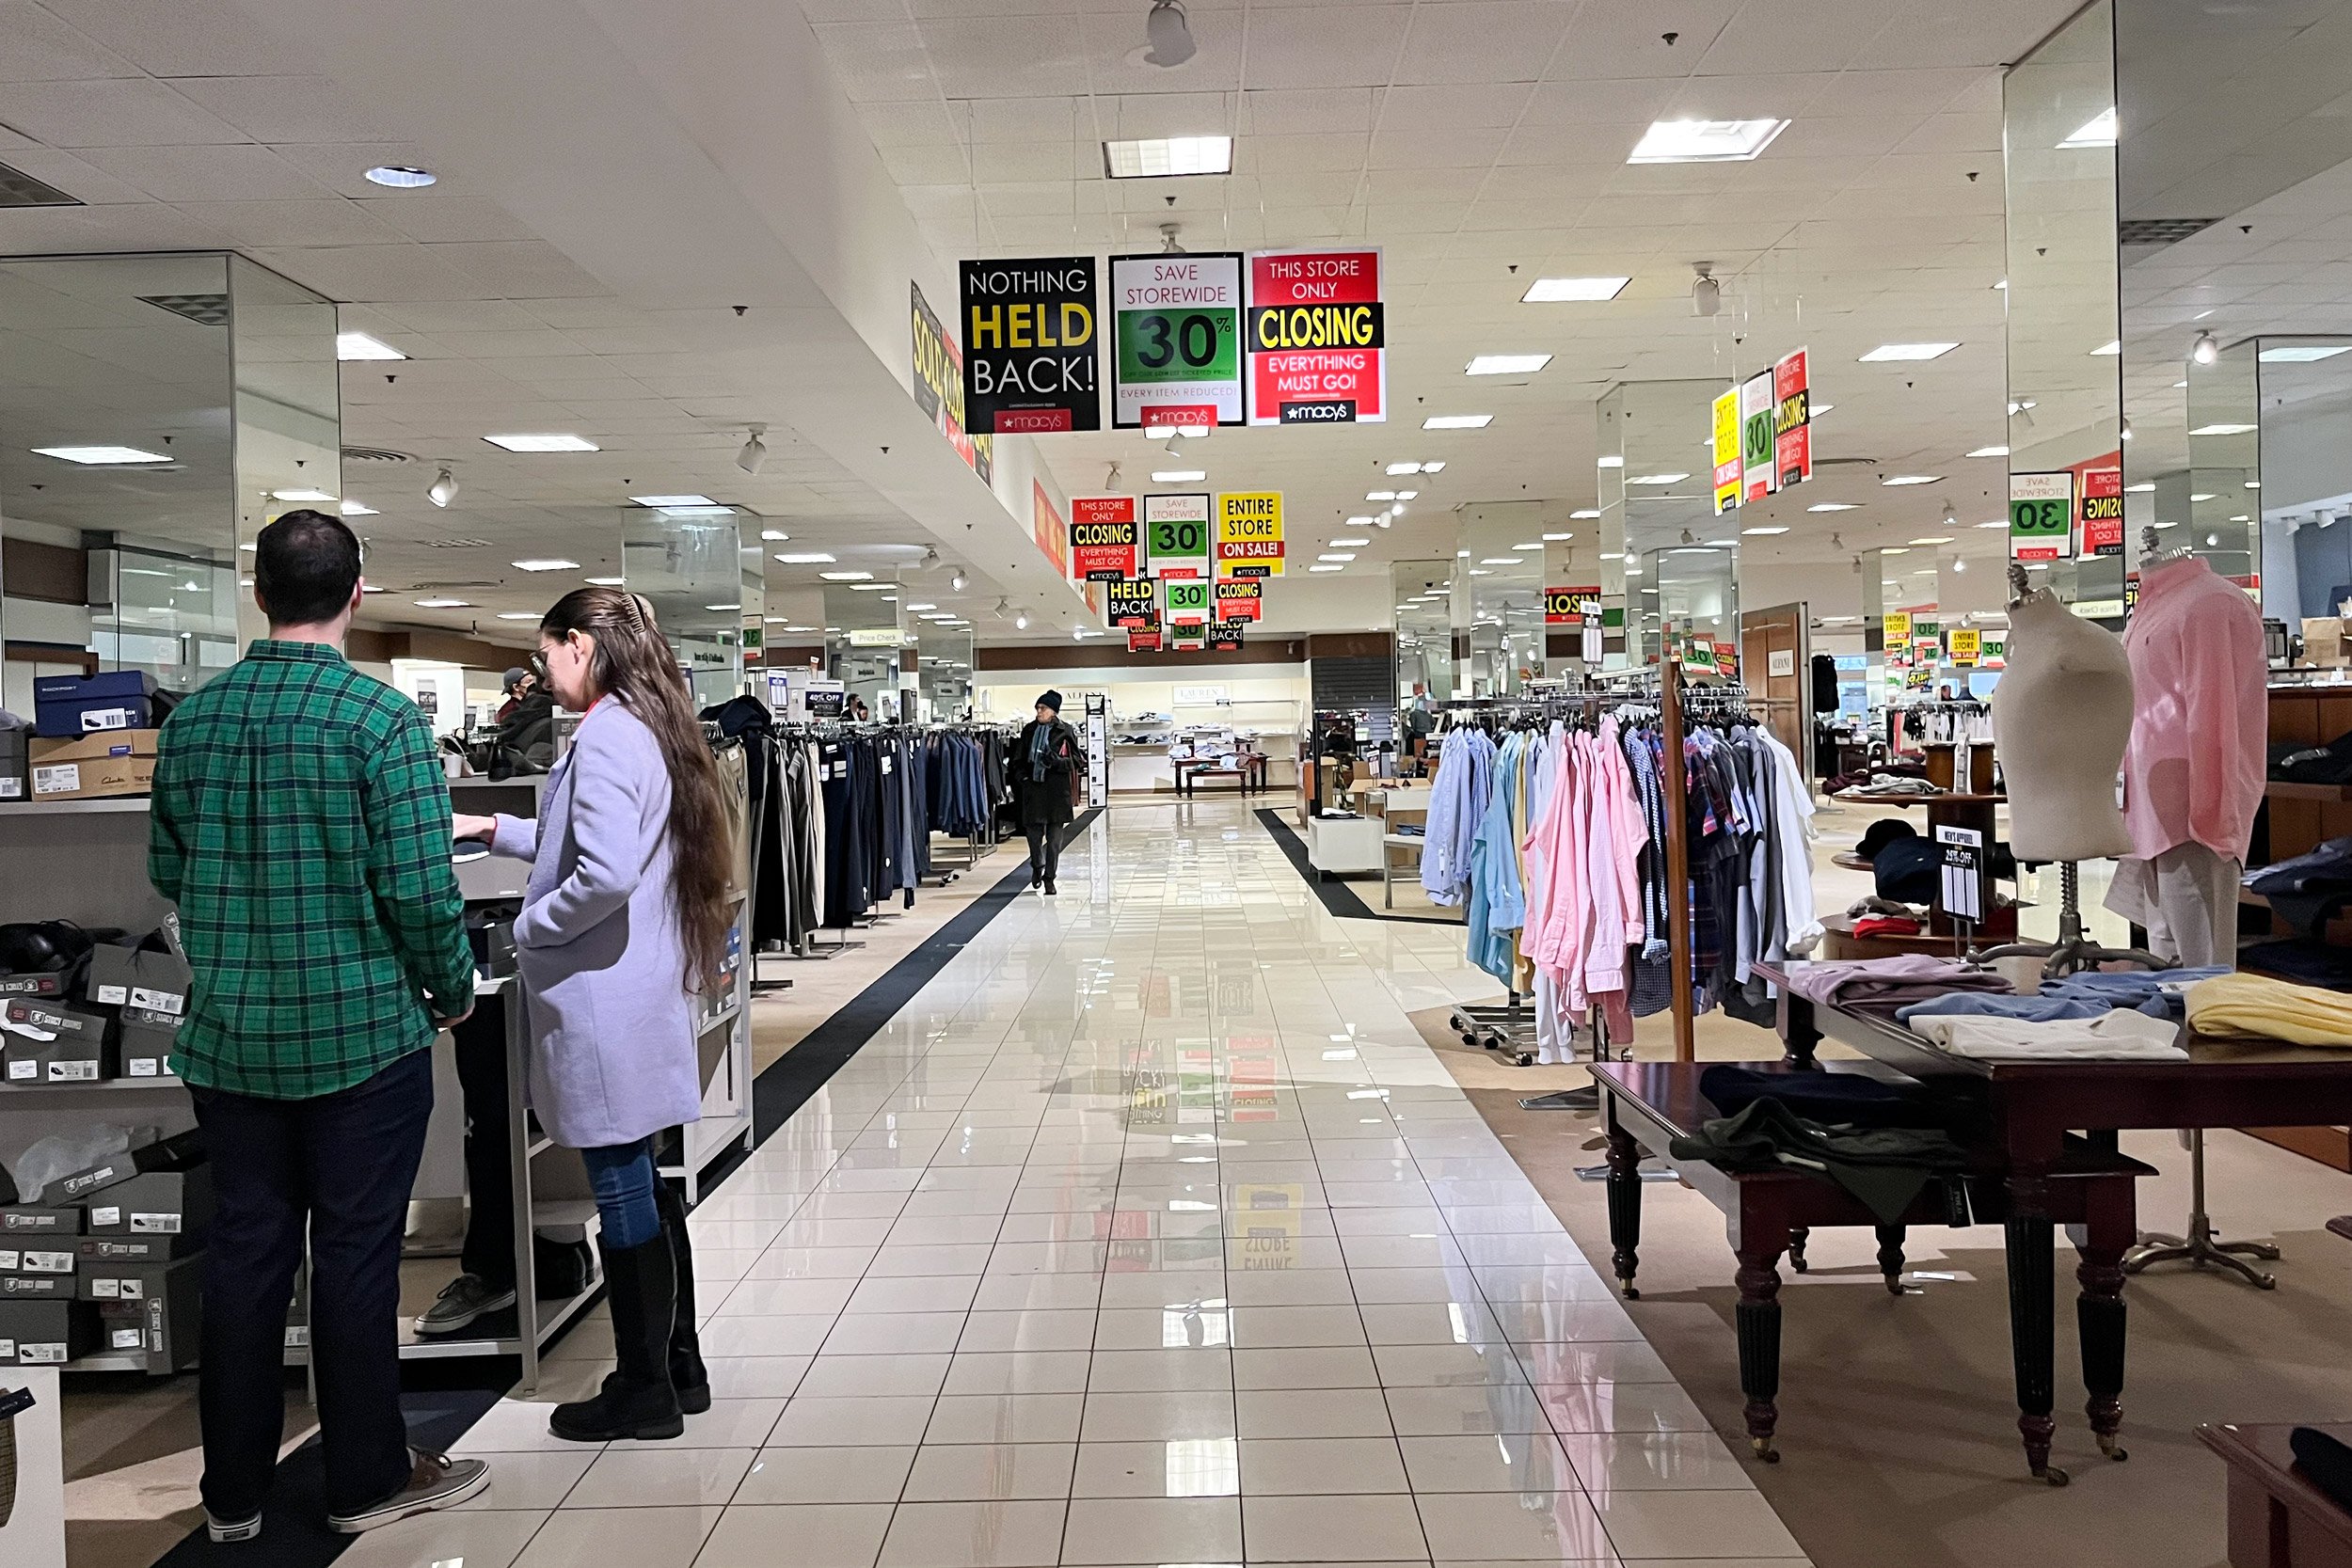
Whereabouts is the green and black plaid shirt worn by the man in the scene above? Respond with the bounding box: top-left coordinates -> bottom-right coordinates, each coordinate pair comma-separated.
149,640 -> 473,1101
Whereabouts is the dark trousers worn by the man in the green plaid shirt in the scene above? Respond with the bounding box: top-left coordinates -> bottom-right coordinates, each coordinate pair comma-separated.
191,1051 -> 433,1519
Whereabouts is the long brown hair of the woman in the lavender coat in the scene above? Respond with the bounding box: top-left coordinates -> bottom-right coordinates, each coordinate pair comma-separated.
539,588 -> 732,992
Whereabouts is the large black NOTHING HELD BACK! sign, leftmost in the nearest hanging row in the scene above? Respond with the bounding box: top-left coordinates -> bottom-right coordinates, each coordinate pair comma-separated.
962,256 -> 1104,435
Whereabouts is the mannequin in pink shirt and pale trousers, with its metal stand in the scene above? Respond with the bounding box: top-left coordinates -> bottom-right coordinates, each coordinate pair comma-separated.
2107,529 -> 2280,1291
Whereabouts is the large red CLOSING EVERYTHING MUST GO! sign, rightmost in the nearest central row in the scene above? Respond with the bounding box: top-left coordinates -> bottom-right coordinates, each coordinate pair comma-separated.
1249,249 -> 1388,425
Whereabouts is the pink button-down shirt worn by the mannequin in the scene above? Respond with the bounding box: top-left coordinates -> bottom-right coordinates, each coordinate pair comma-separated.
2124,560 -> 2270,861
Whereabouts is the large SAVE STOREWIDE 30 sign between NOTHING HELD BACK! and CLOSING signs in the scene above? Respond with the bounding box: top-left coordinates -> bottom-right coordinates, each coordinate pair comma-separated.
1110,254 -> 1245,430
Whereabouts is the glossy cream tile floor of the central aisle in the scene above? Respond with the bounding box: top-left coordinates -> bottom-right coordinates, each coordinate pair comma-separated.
342,801 -> 1802,1568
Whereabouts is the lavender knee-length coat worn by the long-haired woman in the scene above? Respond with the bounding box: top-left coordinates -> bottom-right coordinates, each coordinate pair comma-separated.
492,696 -> 704,1149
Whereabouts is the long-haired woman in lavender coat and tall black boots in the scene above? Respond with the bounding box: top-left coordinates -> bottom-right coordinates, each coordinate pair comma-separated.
454,588 -> 732,1444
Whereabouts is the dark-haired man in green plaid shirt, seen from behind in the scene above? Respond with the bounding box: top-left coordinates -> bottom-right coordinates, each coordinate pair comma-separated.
149,510 -> 489,1543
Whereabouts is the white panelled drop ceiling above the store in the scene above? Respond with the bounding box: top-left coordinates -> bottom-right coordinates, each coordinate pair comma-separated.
0,0 -> 2258,637
